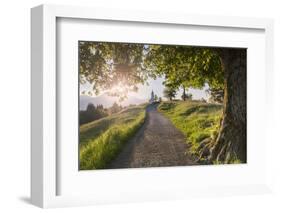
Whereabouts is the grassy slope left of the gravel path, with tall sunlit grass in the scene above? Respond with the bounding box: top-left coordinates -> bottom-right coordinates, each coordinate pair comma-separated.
79,104 -> 146,170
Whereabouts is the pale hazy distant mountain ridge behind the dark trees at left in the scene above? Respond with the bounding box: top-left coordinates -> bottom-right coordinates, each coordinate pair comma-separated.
77,94 -> 147,110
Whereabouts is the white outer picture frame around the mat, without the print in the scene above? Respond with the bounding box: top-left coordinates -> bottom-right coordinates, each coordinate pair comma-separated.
31,5 -> 274,208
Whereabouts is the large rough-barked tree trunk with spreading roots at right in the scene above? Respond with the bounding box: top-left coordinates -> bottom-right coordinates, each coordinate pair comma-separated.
210,49 -> 247,163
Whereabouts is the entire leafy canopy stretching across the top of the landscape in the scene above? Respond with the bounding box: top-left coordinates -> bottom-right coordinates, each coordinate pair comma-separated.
79,41 -> 224,100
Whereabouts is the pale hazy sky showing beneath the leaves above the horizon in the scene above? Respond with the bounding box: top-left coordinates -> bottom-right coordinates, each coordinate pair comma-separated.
80,78 -> 208,100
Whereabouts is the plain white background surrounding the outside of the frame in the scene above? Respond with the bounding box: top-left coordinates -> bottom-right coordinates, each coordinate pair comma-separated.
0,0 -> 281,213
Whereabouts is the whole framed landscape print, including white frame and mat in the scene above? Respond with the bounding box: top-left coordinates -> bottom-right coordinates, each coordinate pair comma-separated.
31,5 -> 273,207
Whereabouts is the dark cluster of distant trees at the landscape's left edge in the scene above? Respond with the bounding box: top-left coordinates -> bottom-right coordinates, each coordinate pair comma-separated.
79,104 -> 108,125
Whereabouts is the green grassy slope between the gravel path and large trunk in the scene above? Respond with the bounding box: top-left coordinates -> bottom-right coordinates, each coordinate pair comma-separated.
158,101 -> 222,159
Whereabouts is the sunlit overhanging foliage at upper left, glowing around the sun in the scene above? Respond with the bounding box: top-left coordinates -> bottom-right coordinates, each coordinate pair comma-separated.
79,41 -> 149,100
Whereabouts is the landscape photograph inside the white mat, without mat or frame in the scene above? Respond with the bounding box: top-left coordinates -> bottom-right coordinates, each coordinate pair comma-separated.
77,41 -> 247,170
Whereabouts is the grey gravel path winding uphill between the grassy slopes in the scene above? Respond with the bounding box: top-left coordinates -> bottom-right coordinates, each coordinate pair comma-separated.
109,104 -> 196,169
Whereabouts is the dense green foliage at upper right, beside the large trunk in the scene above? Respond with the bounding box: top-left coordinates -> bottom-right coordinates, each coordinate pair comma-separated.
145,45 -> 224,91
